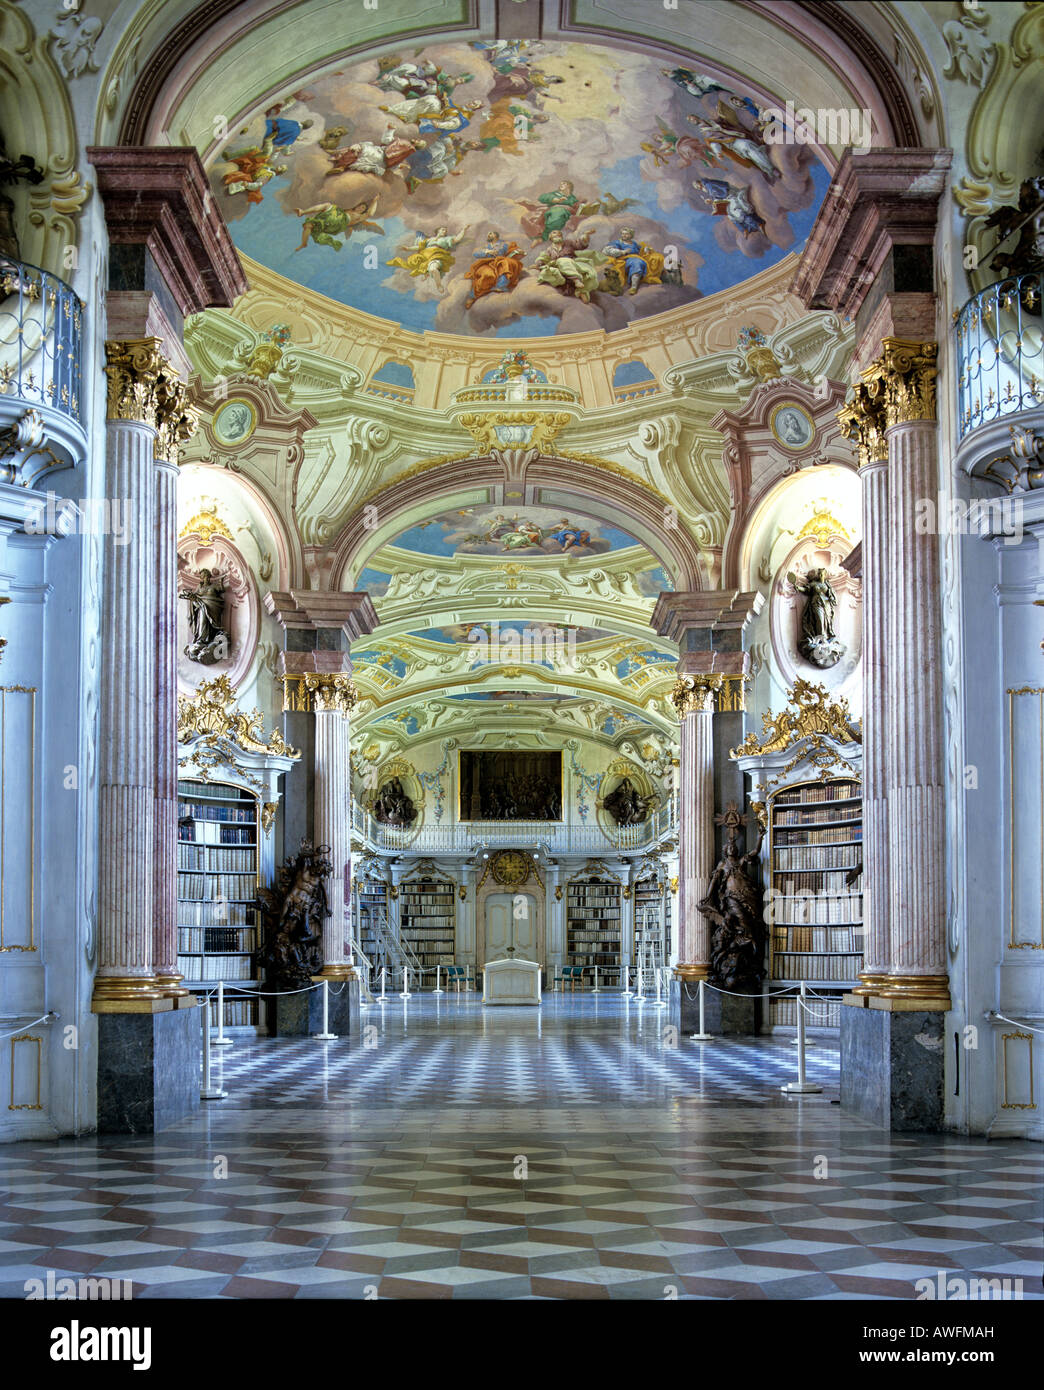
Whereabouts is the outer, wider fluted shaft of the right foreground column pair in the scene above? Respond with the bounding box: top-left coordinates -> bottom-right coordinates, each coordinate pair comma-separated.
886,420 -> 947,995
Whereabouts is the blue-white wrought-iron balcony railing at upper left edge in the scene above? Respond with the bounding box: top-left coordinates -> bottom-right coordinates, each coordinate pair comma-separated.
0,257 -> 83,424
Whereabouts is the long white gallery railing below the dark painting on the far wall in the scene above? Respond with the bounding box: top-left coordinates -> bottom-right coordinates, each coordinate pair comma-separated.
352,802 -> 676,855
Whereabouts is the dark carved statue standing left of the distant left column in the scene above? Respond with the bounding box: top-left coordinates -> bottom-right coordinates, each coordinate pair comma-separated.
257,840 -> 334,990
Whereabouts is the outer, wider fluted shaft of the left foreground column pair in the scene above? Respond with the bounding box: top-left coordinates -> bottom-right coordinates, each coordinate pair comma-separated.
95,418 -> 161,999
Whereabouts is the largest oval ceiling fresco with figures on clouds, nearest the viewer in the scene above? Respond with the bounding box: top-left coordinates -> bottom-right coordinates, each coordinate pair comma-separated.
210,39 -> 829,336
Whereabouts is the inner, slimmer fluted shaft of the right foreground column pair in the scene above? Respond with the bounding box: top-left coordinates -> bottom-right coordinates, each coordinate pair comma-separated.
855,459 -> 894,994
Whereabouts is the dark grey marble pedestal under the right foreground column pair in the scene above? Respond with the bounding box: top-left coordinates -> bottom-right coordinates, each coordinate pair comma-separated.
841,1005 -> 945,1133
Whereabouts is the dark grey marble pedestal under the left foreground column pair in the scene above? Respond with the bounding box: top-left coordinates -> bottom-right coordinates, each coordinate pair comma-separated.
97,999 -> 203,1134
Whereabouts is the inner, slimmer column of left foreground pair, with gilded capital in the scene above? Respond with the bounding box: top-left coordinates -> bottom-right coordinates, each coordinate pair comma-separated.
152,375 -> 195,998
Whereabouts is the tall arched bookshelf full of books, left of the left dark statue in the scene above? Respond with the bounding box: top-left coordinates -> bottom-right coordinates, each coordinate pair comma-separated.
178,780 -> 260,1027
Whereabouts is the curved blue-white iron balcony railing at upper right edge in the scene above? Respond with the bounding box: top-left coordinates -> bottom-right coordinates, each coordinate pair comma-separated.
954,272 -> 1044,439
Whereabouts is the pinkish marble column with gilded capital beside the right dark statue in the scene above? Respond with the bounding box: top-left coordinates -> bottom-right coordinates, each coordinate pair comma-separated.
671,674 -> 723,983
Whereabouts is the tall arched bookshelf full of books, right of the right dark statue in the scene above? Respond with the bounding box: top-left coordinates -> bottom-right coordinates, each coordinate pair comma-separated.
767,778 -> 863,1027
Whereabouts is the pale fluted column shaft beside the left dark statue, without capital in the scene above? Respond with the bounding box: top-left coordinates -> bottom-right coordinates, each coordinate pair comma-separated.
314,706 -> 352,979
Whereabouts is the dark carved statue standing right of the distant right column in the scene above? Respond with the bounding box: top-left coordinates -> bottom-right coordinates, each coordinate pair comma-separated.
696,828 -> 765,994
